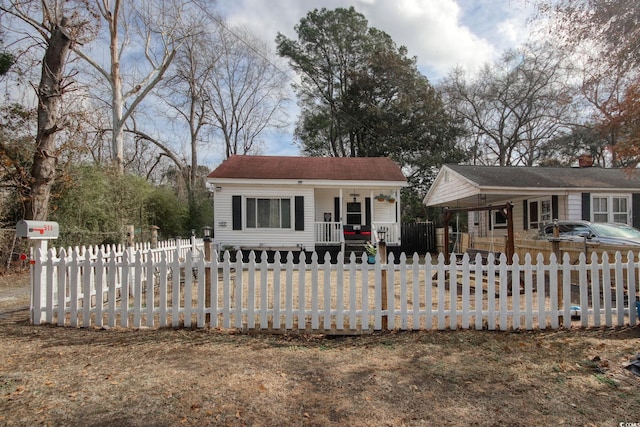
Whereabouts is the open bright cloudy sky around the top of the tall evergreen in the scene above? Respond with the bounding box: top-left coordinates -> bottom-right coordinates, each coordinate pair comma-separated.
206,0 -> 532,164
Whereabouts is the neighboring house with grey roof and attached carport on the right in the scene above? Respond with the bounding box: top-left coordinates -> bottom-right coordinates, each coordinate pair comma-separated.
424,165 -> 640,237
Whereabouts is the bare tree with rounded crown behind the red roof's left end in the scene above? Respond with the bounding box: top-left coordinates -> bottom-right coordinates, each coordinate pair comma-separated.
151,9 -> 286,227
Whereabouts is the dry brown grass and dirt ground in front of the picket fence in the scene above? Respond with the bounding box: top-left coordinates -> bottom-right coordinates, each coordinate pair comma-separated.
0,274 -> 640,426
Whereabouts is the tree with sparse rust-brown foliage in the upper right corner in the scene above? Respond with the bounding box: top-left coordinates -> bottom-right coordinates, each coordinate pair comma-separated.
534,0 -> 640,166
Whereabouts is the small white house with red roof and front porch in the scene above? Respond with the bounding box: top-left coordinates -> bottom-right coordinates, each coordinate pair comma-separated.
207,155 -> 407,253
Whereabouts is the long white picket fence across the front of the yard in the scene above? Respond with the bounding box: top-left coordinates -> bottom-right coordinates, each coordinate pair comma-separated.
31,246 -> 640,334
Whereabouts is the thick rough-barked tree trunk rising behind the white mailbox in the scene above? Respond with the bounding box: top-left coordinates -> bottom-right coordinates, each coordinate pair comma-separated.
25,18 -> 71,221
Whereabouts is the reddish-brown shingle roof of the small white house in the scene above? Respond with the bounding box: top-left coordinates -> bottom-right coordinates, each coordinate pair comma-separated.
209,155 -> 406,182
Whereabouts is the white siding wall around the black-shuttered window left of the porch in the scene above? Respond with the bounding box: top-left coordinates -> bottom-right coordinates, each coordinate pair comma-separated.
213,185 -> 315,250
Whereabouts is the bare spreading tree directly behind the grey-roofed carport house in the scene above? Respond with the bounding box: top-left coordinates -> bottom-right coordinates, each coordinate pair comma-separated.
441,44 -> 573,166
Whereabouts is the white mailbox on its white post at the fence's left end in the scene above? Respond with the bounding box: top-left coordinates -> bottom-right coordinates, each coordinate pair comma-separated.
16,220 -> 60,325
